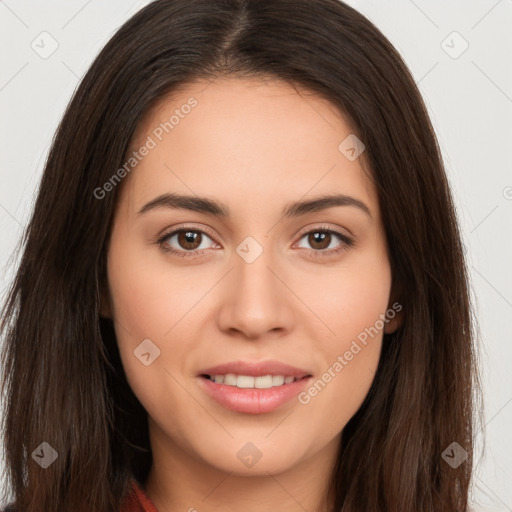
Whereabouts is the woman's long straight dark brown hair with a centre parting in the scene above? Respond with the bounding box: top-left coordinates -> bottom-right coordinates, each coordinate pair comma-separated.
1,0 -> 480,512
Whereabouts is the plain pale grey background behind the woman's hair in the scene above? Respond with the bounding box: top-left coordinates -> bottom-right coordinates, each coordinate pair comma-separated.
0,0 -> 512,512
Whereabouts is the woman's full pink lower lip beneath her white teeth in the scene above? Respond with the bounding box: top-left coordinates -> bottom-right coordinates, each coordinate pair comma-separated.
198,377 -> 311,414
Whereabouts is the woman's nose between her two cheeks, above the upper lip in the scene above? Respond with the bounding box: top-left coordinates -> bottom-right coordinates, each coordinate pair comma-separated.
218,247 -> 296,339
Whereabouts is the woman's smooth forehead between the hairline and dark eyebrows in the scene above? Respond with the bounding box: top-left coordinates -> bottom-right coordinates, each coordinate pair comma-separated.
118,78 -> 377,217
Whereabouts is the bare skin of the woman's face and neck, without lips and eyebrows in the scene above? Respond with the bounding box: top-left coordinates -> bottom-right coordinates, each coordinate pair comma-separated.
103,78 -> 401,512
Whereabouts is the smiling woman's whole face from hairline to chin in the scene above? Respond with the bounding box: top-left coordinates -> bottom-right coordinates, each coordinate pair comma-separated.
107,78 -> 394,474
